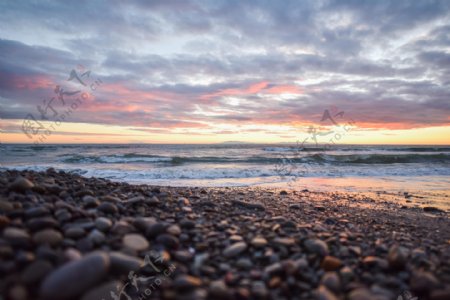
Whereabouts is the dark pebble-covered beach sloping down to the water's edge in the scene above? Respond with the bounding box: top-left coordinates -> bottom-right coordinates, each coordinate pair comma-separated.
0,169 -> 450,300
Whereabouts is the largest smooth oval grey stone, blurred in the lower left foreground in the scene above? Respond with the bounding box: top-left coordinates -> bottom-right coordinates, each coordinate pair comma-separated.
40,252 -> 110,300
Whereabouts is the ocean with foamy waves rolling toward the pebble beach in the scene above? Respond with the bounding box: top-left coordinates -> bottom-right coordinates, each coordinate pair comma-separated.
0,143 -> 450,203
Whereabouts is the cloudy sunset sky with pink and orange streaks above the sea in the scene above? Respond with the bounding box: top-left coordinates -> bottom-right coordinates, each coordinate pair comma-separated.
0,0 -> 450,144
